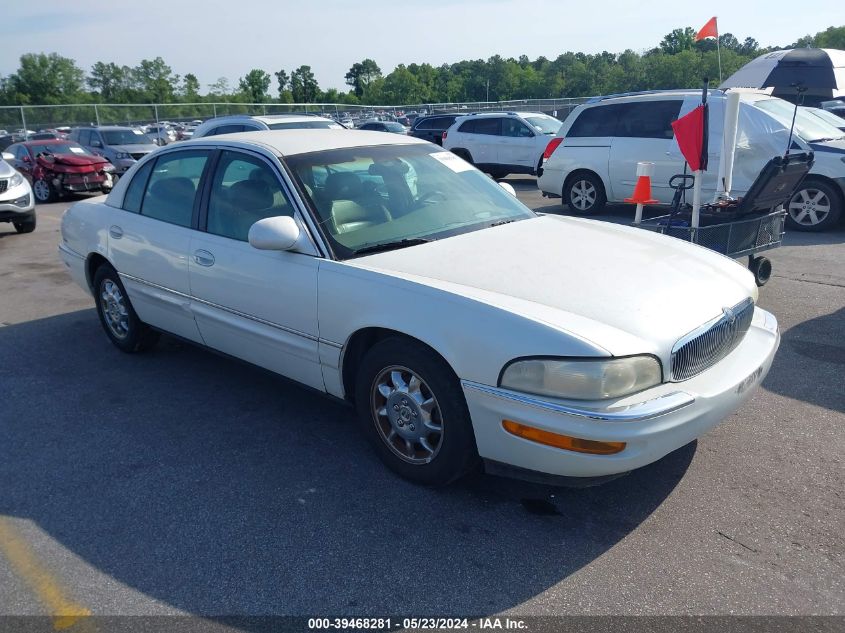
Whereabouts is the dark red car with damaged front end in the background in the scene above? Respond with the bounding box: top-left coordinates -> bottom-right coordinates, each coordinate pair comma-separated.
6,139 -> 114,203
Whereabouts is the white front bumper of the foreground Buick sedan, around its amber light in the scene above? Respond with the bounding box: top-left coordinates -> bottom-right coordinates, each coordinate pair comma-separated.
461,308 -> 780,477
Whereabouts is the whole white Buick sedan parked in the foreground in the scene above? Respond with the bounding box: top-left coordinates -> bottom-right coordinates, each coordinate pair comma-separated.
59,130 -> 779,484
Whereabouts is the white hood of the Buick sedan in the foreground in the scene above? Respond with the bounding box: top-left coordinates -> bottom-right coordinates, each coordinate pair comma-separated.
348,216 -> 756,358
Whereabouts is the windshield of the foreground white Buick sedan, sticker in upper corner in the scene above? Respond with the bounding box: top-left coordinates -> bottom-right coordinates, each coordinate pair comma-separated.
285,144 -> 536,259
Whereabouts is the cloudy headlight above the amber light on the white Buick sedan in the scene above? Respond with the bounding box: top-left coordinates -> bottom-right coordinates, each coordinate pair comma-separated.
499,356 -> 663,400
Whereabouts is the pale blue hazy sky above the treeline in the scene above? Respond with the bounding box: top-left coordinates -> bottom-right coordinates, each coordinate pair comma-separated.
0,0 -> 845,91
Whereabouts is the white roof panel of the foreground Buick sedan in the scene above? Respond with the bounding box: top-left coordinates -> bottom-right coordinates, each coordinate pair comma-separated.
179,129 -> 426,156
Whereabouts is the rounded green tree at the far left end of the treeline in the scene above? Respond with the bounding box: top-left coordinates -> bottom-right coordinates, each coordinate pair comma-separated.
5,53 -> 85,104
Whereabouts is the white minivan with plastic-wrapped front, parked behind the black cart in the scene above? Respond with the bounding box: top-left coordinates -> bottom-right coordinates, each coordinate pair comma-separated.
538,90 -> 845,231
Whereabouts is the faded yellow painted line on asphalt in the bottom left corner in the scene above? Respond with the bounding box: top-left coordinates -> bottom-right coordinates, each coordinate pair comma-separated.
0,516 -> 91,631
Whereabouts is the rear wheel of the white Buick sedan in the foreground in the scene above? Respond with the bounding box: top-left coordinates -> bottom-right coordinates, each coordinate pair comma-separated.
94,264 -> 160,353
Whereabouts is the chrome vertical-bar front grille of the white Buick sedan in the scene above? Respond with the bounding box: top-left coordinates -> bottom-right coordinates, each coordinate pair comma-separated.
672,298 -> 754,381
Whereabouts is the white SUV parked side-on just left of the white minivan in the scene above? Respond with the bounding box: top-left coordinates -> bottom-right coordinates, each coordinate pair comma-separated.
443,112 -> 561,178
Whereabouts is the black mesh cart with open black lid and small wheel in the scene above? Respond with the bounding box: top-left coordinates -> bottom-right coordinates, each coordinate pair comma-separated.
635,152 -> 813,286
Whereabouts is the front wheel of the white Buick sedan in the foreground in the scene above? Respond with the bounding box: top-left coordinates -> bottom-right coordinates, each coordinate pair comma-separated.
355,337 -> 479,486
